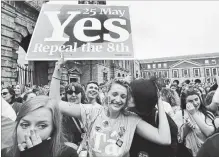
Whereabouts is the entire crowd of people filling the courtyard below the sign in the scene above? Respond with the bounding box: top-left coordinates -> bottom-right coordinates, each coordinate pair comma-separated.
2,60 -> 219,157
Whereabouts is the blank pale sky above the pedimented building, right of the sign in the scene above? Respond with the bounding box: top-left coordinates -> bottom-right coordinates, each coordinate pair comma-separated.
50,0 -> 219,59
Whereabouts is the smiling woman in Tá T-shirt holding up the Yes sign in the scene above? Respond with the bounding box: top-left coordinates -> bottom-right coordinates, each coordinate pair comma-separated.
50,55 -> 171,157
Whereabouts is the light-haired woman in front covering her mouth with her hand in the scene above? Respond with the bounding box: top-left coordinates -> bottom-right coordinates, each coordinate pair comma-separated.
2,96 -> 77,157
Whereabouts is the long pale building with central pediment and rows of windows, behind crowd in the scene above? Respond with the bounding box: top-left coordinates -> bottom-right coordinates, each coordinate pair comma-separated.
141,53 -> 219,83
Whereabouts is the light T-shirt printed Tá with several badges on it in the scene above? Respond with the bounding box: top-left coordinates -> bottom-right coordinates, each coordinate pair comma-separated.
81,104 -> 141,157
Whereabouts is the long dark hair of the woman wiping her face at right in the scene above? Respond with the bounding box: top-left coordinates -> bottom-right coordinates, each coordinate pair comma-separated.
181,88 -> 213,121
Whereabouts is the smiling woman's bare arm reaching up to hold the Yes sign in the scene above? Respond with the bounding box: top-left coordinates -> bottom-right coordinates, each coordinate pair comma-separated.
49,57 -> 81,119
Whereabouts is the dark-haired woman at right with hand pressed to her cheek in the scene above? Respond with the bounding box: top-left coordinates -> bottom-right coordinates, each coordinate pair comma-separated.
174,88 -> 215,157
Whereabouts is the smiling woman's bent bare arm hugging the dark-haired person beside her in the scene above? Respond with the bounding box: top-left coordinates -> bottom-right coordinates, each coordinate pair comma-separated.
136,98 -> 171,145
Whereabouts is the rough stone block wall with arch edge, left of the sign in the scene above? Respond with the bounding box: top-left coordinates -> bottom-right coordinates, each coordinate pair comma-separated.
1,0 -> 43,86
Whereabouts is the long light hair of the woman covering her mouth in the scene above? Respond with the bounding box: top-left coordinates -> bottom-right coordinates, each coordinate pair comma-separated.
7,95 -> 66,157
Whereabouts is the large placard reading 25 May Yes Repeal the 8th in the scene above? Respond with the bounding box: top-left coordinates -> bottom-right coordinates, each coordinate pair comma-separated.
26,4 -> 134,60
